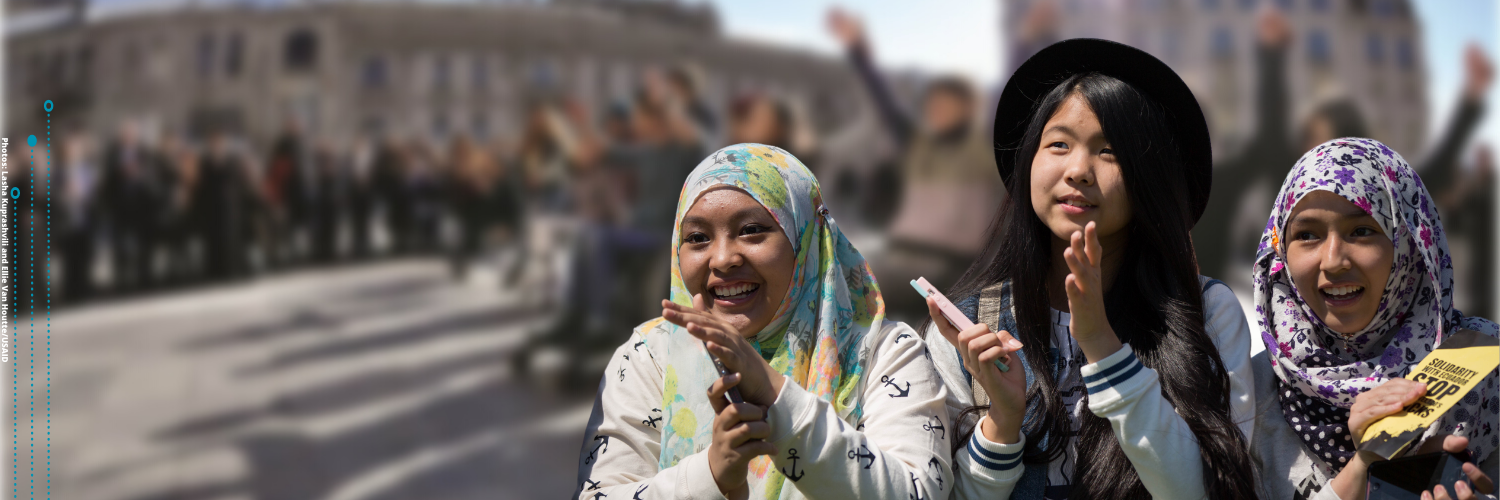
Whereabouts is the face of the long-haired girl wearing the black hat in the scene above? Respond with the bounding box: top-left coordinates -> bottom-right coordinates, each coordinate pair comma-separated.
1031,93 -> 1131,246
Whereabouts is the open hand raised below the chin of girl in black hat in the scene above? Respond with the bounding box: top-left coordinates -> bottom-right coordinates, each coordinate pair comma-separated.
1062,222 -> 1121,363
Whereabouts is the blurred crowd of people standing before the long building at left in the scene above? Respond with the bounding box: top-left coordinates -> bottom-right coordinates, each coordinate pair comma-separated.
32,66 -> 822,323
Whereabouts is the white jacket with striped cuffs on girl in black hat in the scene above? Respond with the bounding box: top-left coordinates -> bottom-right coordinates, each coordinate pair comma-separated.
927,278 -> 1256,500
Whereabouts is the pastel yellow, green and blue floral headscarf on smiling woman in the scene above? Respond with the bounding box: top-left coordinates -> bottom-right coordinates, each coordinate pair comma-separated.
636,144 -> 885,498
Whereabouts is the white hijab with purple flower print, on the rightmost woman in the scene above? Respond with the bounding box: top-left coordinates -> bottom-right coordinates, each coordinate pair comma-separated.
1254,138 -> 1500,473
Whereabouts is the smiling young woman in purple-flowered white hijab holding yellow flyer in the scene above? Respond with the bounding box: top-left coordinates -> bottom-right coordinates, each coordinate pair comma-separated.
1254,138 -> 1500,498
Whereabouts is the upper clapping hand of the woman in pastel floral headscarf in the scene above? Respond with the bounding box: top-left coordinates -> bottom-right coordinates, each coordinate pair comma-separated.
662,294 -> 786,407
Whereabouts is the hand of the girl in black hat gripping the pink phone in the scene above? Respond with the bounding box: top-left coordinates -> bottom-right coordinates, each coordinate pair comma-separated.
927,297 -> 1026,444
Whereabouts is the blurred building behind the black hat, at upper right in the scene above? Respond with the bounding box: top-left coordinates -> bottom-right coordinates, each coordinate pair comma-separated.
1002,0 -> 1428,156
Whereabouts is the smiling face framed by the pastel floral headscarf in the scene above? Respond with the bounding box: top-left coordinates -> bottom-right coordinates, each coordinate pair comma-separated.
677,186 -> 797,338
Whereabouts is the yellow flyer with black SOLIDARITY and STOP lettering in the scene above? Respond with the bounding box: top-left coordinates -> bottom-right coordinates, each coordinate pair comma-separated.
1359,330 -> 1500,459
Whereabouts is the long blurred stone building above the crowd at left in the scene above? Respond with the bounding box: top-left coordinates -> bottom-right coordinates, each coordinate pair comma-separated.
6,0 -> 863,144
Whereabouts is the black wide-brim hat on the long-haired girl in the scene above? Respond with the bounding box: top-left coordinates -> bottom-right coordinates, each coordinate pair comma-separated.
995,38 -> 1214,222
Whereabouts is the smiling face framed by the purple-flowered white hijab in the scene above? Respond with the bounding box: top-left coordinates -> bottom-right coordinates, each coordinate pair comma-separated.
1286,191 -> 1395,335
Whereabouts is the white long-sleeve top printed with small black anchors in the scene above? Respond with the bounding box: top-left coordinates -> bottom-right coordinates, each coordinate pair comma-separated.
576,321 -> 954,500
